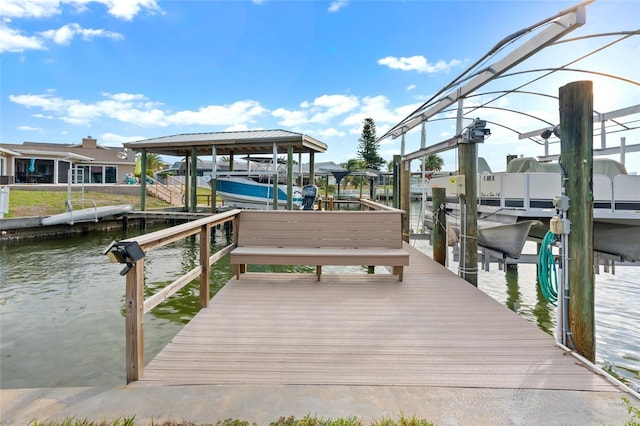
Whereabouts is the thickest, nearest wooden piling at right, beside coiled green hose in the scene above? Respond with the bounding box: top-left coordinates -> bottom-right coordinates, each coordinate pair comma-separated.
560,81 -> 595,361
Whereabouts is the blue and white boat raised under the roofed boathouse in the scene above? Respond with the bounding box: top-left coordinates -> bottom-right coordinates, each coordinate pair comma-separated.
216,176 -> 302,209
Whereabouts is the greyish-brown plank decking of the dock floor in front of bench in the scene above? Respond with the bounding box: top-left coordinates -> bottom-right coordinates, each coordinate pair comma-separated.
137,245 -> 619,392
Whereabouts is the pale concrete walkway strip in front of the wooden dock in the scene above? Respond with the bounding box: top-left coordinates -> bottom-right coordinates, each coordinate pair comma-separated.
0,385 -> 640,426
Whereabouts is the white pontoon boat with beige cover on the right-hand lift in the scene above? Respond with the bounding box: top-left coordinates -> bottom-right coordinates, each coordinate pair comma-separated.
427,158 -> 640,261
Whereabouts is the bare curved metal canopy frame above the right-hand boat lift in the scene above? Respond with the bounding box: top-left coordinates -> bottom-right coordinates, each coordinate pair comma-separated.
379,1 -> 640,168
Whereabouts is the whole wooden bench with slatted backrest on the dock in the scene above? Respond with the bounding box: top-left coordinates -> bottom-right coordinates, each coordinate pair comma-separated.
230,210 -> 409,281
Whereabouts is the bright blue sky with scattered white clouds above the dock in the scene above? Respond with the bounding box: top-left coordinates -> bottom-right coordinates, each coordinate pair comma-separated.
0,0 -> 640,171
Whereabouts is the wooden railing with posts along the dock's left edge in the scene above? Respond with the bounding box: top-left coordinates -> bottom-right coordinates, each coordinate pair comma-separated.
121,209 -> 241,383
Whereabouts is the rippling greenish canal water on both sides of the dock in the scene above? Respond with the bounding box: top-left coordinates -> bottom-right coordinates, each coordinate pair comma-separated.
0,220 -> 640,389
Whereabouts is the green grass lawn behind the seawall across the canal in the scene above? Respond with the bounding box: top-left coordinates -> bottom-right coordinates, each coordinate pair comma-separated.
4,189 -> 171,218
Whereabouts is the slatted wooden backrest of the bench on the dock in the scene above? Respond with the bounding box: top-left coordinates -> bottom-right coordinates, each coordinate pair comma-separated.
236,210 -> 402,248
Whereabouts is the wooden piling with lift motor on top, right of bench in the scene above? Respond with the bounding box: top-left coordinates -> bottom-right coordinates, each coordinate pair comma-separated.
458,141 -> 478,287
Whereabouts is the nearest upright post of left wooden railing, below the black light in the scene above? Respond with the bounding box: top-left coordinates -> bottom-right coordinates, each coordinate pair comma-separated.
125,259 -> 144,383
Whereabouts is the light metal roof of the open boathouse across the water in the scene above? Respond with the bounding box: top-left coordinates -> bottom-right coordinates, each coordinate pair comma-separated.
123,129 -> 327,156
